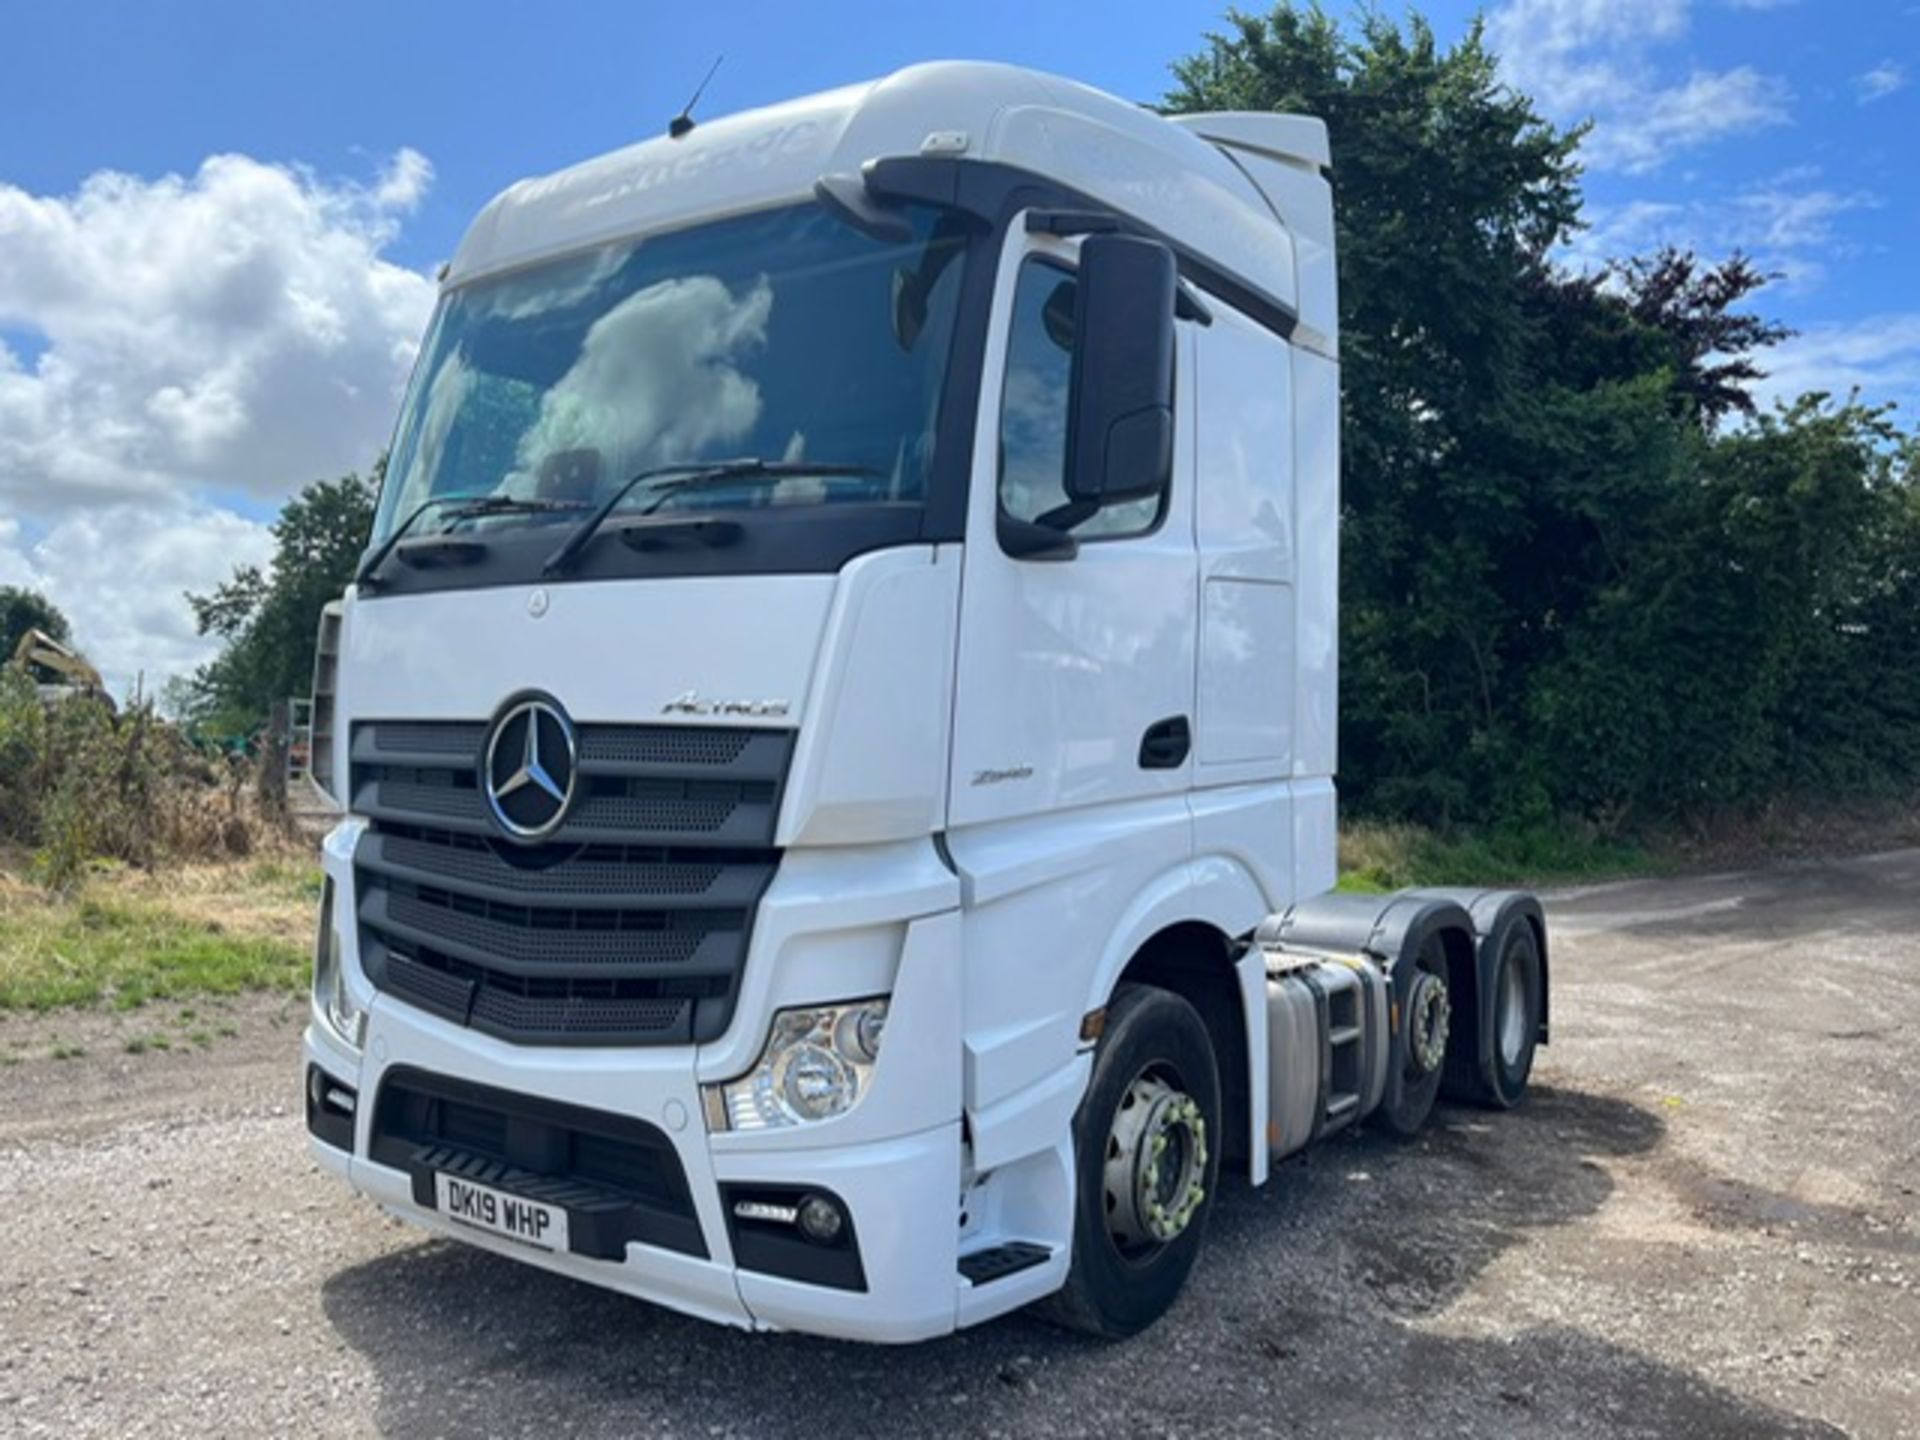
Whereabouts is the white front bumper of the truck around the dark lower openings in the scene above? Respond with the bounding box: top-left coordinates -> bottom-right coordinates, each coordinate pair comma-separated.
305,845 -> 966,1342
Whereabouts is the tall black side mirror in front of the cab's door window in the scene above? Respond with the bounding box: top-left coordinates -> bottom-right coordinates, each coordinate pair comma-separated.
1066,234 -> 1179,505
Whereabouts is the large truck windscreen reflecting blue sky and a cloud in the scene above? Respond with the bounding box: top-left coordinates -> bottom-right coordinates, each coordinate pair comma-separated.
374,204 -> 964,543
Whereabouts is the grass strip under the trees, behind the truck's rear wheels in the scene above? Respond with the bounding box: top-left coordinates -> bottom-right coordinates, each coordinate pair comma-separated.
1340,820 -> 1665,893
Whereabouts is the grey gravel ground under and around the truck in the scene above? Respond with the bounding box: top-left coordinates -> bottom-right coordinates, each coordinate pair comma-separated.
0,851 -> 1920,1438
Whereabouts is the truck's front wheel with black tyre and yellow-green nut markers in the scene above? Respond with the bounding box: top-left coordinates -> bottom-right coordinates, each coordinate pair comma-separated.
1039,985 -> 1225,1340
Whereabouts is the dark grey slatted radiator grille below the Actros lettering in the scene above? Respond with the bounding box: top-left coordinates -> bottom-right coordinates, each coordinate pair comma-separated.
351,720 -> 793,1044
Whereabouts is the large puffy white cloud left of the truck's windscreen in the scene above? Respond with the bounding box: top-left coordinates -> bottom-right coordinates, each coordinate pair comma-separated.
0,150 -> 434,685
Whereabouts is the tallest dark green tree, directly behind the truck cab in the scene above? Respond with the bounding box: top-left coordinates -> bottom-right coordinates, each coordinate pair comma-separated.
1167,6 -> 1580,820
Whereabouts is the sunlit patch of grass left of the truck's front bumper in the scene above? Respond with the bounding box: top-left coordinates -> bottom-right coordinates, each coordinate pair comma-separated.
0,860 -> 321,1013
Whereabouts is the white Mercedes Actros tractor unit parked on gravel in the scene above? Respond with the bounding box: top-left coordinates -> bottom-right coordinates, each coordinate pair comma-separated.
305,63 -> 1548,1342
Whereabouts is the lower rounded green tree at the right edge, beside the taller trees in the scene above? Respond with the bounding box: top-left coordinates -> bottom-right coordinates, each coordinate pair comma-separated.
1526,397 -> 1920,814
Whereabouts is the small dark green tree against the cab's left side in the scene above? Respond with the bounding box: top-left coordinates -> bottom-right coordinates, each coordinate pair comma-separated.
185,459 -> 386,735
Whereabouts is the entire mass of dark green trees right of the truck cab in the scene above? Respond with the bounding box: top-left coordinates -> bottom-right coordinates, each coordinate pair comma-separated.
1167,4 -> 1920,833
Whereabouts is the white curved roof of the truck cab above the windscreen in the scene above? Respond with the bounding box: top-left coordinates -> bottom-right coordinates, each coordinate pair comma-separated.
445,61 -> 1327,343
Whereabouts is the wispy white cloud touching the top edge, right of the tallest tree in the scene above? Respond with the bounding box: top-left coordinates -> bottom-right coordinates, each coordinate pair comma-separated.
1488,0 -> 1791,175
